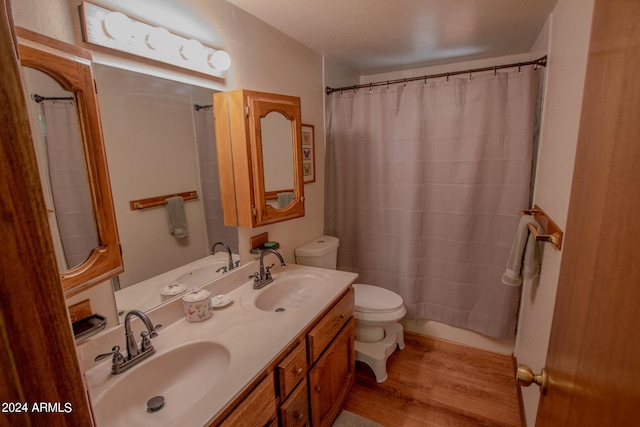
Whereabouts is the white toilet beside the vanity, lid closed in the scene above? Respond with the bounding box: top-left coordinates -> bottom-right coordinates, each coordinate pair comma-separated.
295,236 -> 407,383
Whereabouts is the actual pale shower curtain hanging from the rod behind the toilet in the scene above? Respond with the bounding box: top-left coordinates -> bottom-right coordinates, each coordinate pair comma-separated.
325,67 -> 542,338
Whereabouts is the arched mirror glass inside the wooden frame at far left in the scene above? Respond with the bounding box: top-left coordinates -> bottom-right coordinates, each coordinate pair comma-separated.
22,67 -> 99,271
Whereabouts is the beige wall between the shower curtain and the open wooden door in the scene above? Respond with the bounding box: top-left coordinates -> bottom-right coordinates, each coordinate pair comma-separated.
515,0 -> 593,426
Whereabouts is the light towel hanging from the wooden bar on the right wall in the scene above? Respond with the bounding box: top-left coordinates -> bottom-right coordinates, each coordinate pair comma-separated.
502,215 -> 541,286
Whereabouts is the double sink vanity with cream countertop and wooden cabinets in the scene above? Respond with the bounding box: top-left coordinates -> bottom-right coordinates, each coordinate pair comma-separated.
78,260 -> 357,427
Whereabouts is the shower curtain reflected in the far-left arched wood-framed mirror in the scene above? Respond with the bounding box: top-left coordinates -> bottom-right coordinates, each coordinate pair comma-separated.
41,101 -> 99,269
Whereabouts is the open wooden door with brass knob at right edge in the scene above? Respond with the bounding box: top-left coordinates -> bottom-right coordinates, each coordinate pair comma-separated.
536,0 -> 640,426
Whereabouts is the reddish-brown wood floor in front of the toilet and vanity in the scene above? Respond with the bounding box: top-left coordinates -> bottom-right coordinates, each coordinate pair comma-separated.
343,332 -> 524,427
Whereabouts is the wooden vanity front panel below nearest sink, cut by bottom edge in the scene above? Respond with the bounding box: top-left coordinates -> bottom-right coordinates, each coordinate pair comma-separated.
220,374 -> 278,427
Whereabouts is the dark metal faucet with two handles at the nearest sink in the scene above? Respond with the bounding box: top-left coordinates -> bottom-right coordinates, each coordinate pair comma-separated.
95,310 -> 162,375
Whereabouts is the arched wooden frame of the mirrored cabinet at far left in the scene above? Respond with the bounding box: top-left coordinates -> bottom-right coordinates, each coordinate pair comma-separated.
16,28 -> 124,297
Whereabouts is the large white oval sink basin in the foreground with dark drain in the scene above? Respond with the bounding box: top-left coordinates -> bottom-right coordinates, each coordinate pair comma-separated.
92,341 -> 230,427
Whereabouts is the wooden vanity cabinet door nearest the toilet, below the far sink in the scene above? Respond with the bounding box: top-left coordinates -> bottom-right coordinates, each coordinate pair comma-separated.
309,319 -> 355,427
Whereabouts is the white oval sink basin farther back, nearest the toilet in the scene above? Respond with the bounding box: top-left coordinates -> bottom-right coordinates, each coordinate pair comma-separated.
254,274 -> 327,312
